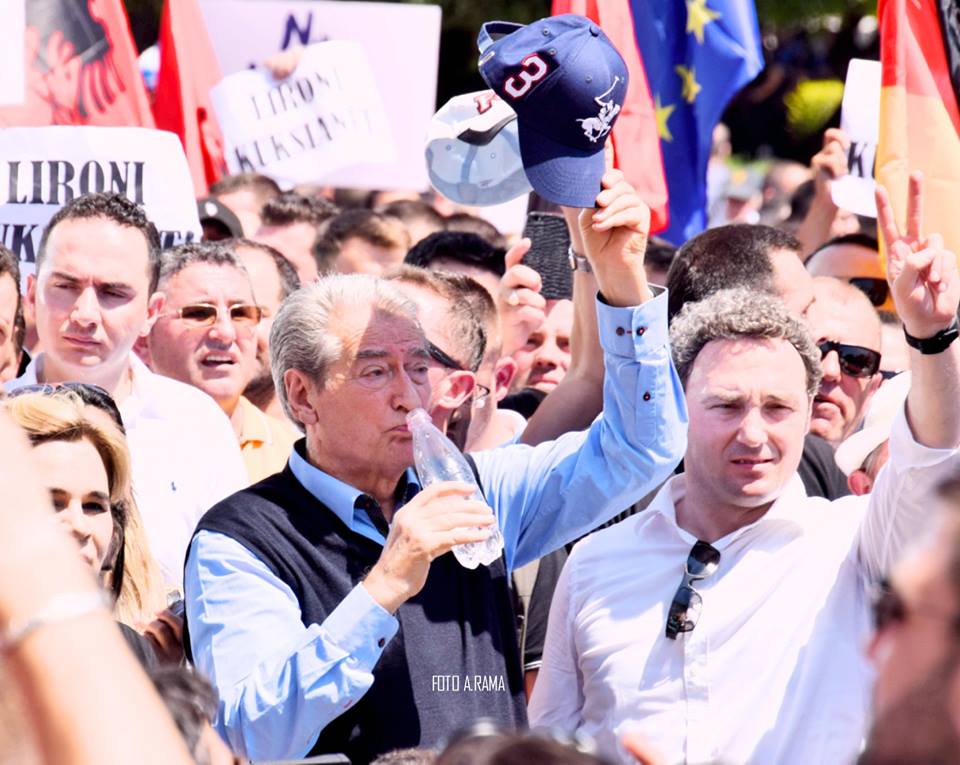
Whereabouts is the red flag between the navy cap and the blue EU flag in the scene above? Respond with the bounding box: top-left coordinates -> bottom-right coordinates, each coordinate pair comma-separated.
553,0 -> 668,233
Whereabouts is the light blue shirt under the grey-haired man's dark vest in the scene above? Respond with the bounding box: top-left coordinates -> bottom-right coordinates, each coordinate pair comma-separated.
184,292 -> 687,760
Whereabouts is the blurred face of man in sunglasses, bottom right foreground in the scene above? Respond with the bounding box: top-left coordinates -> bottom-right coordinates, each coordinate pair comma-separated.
857,477 -> 960,765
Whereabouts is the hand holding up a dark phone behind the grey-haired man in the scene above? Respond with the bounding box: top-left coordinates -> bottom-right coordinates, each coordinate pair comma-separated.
497,239 -> 547,356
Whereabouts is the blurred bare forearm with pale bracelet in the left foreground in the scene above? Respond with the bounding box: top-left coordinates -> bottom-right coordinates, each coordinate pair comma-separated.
0,413 -> 193,765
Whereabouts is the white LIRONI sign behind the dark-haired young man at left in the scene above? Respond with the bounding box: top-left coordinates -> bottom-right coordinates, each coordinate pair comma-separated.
0,126 -> 200,280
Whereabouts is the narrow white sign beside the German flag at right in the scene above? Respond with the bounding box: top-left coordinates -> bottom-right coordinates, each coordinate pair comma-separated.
830,58 -> 880,218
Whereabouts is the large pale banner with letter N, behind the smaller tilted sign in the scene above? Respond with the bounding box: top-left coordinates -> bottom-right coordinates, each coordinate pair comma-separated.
200,0 -> 440,190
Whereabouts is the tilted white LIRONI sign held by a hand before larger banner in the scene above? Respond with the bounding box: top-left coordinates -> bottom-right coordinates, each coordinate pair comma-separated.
211,41 -> 394,186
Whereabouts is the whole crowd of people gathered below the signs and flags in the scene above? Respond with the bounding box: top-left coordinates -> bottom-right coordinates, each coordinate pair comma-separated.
0,17 -> 960,765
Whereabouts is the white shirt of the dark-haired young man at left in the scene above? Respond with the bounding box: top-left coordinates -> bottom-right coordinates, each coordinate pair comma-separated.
6,353 -> 250,588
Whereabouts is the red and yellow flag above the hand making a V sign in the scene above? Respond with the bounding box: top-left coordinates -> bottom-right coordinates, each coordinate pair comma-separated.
876,0 -> 960,254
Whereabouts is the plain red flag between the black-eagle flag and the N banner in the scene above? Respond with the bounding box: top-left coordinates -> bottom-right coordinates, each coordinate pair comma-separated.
153,0 -> 224,197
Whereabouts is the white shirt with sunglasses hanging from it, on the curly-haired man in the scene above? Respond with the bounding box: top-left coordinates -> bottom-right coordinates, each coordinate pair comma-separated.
529,402 -> 957,765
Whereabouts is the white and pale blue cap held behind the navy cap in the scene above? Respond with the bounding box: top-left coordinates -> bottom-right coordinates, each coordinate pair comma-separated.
426,90 -> 532,206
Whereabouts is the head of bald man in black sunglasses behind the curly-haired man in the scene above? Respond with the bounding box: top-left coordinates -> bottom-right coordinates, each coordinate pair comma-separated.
807,276 -> 882,447
